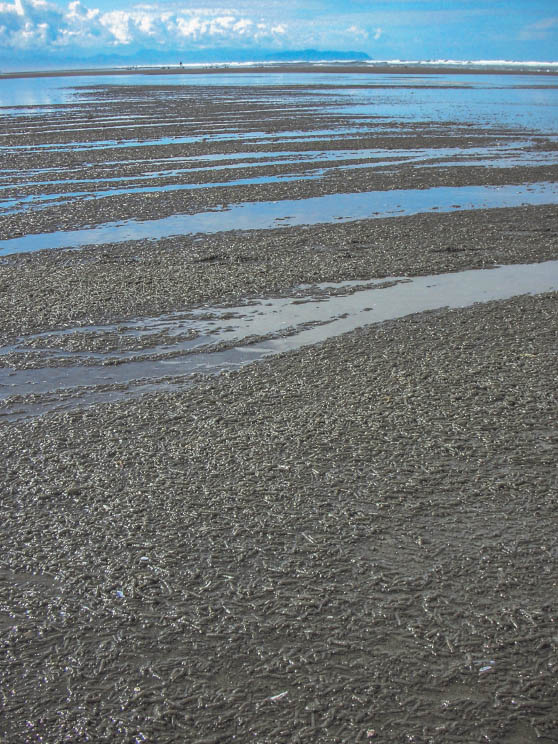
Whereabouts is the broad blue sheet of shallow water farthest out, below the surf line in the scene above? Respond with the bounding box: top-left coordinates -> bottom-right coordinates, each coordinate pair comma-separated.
0,72 -> 558,133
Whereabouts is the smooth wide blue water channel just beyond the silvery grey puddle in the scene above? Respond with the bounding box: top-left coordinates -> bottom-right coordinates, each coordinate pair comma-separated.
0,182 -> 558,256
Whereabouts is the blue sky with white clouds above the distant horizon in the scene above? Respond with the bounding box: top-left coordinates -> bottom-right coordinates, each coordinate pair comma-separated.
0,0 -> 558,65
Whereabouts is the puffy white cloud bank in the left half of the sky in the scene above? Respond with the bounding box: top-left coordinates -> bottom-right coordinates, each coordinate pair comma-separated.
0,0 -> 296,52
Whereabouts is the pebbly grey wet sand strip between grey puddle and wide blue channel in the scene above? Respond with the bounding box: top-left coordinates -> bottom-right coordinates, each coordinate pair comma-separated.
0,206 -> 558,343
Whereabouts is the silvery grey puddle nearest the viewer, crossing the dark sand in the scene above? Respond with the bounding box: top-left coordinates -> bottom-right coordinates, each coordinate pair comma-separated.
0,261 -> 558,421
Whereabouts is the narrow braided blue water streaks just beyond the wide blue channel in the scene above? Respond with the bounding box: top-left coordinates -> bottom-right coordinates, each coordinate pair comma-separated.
0,143 -> 558,214
